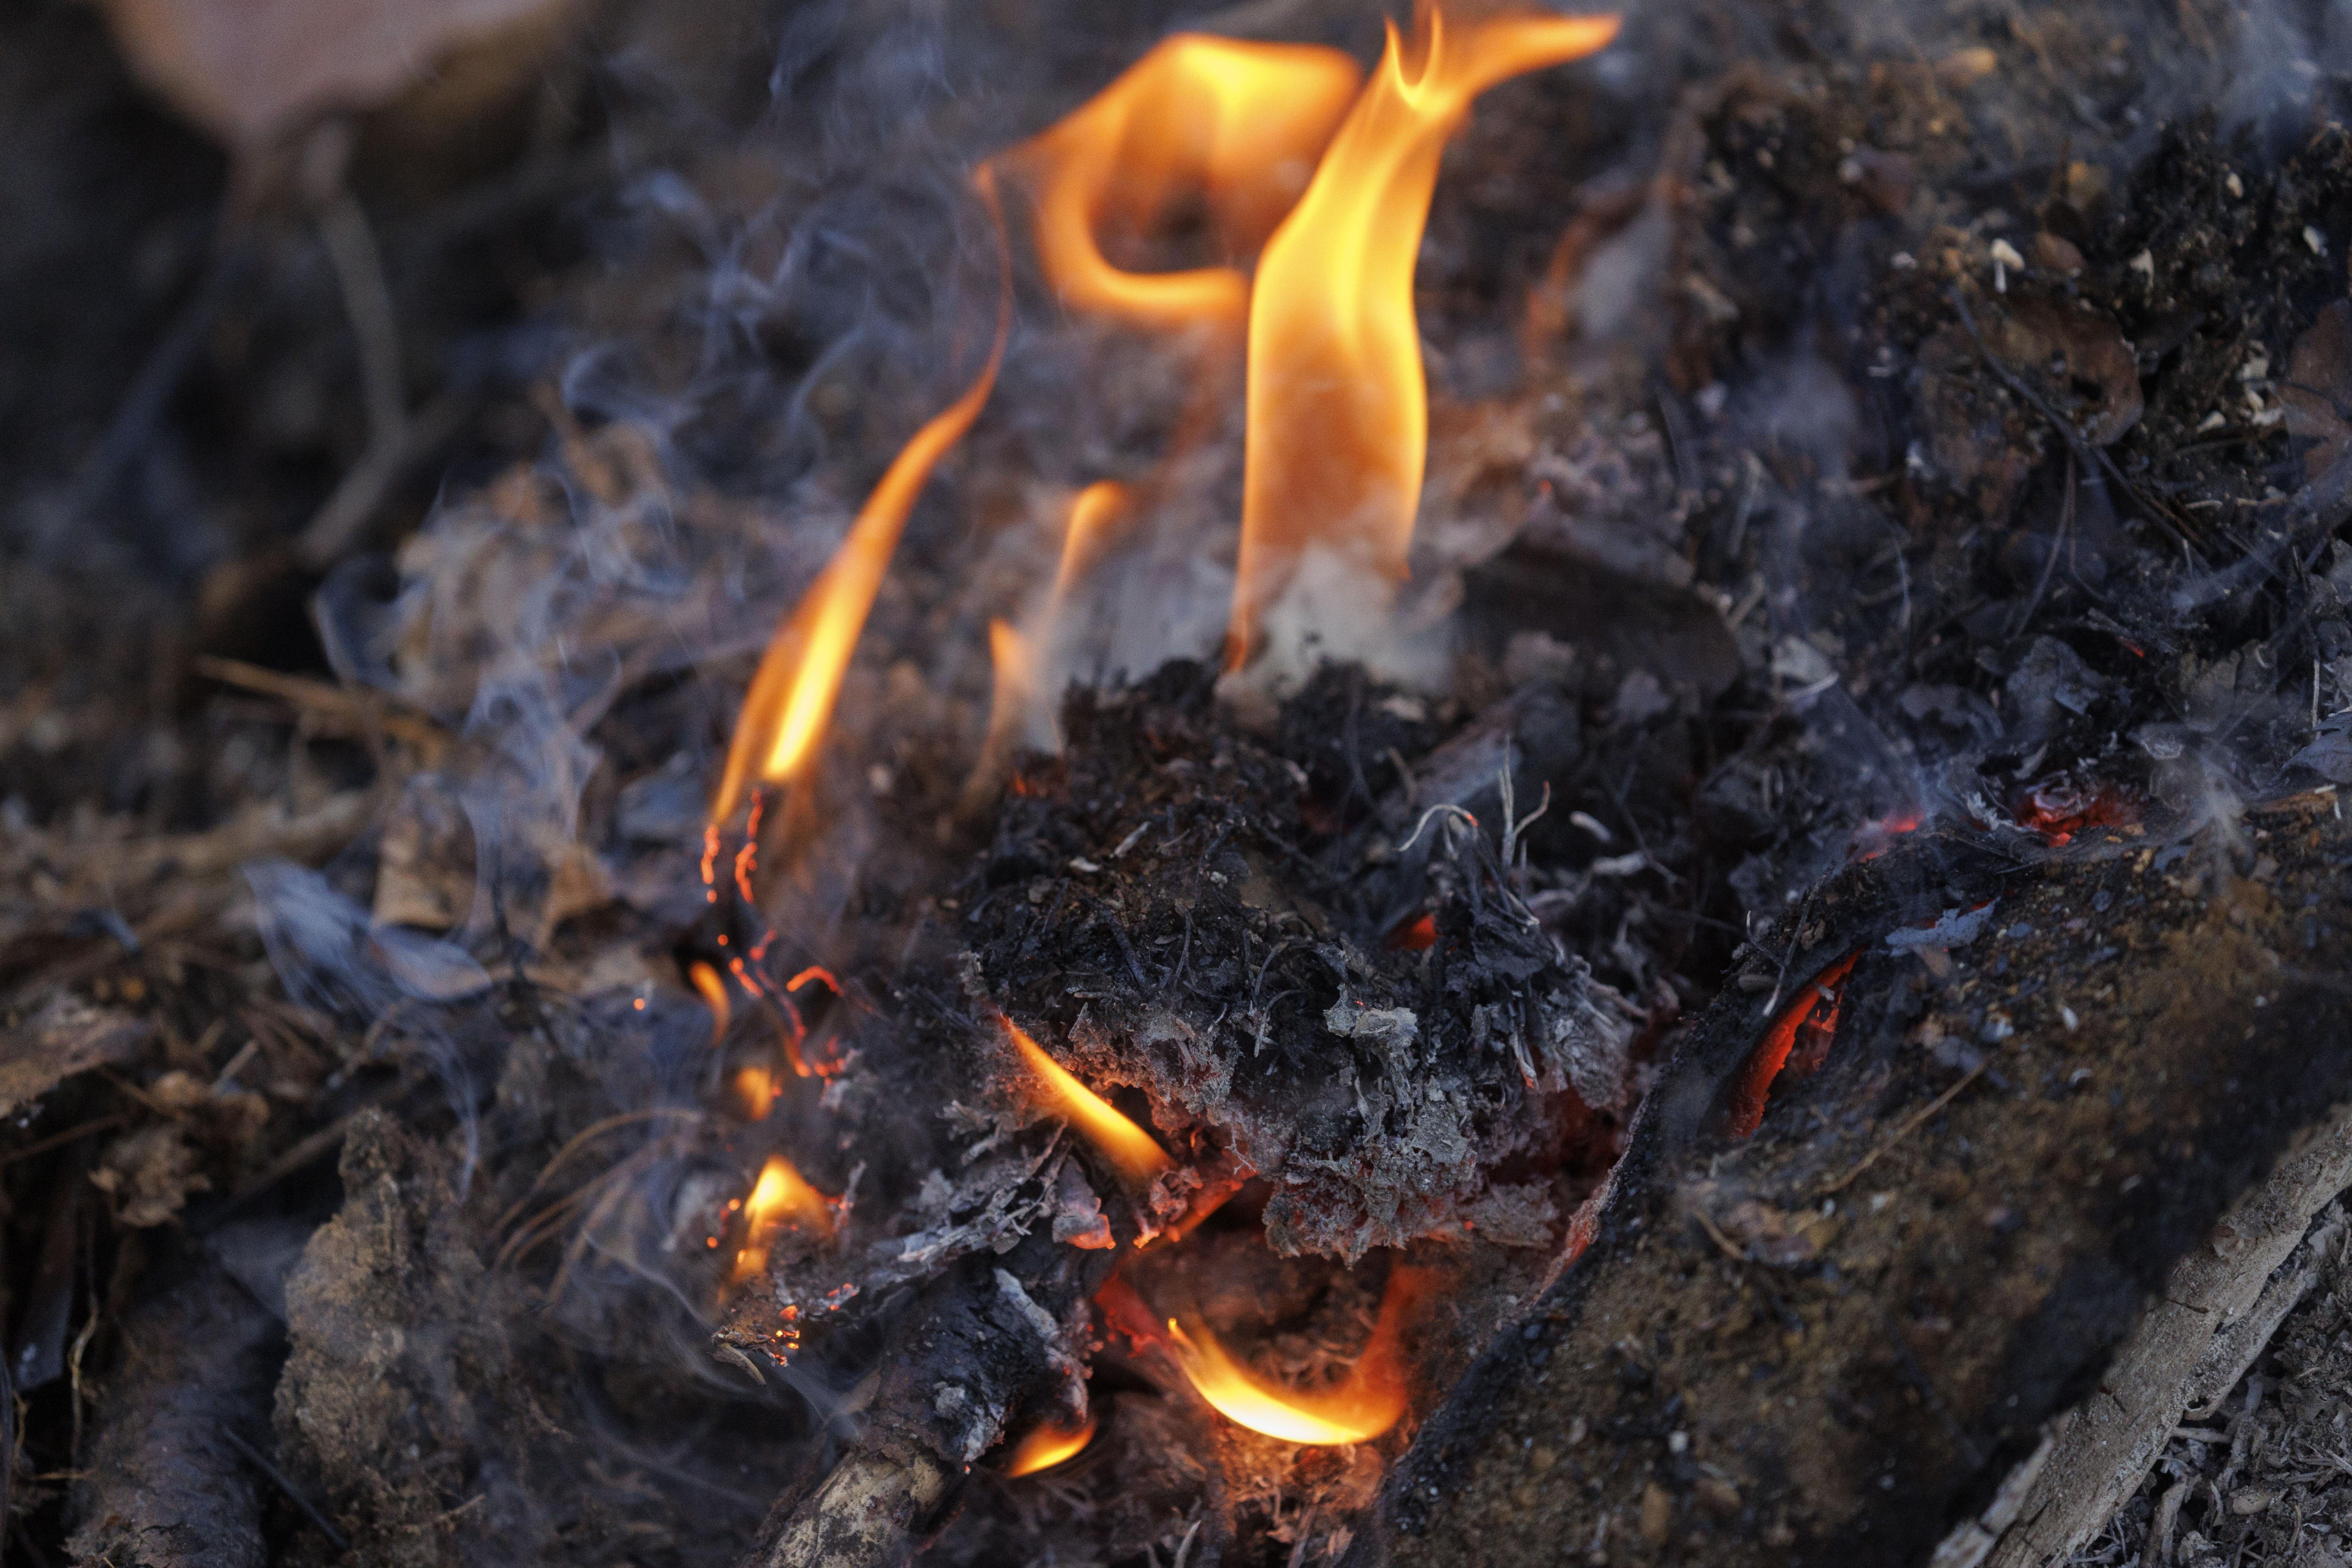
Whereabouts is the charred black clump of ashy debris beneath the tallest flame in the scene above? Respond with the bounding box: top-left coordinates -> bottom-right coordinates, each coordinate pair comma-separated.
964,665 -> 1637,1262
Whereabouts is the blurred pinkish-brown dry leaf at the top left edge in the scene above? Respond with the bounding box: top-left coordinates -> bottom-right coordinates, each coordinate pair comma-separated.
101,0 -> 569,148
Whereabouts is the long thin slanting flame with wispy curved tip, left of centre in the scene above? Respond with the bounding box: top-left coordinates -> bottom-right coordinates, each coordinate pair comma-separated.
710,175 -> 1014,823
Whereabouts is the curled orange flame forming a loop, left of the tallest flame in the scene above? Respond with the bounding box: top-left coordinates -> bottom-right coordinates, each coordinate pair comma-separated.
1011,33 -> 1362,332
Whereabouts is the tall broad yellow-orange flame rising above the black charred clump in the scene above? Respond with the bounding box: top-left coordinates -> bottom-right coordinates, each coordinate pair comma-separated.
1228,5 -> 1618,668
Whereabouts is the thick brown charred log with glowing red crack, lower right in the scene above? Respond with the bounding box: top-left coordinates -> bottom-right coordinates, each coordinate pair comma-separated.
1348,795 -> 2352,1568
